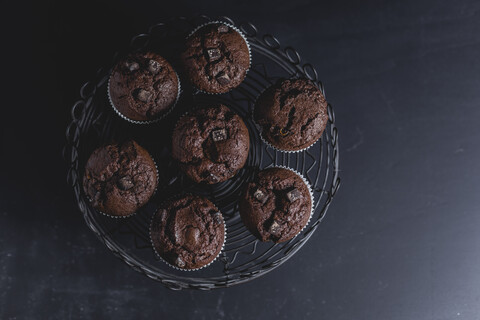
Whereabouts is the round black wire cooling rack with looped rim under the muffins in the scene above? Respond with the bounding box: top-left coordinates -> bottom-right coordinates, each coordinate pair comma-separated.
64,16 -> 340,290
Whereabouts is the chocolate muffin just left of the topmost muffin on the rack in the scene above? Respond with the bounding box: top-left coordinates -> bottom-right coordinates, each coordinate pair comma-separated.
108,52 -> 179,122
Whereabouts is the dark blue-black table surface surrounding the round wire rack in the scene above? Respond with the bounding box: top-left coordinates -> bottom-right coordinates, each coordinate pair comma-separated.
0,0 -> 480,320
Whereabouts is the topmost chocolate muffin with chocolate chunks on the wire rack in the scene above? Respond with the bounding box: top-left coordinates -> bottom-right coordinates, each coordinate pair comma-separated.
181,23 -> 250,93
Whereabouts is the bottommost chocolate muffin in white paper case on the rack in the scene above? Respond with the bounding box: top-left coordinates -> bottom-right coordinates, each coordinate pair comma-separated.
150,195 -> 225,270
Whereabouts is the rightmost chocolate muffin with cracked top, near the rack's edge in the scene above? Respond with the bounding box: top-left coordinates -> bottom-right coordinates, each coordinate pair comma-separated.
254,79 -> 328,151
